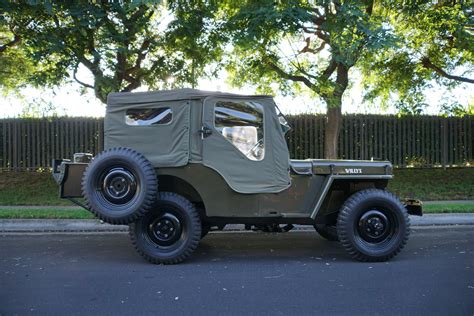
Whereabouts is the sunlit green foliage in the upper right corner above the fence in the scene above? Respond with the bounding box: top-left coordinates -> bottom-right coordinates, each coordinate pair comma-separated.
361,0 -> 474,107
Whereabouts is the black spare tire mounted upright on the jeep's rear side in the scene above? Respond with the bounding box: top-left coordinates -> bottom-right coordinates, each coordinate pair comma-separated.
82,147 -> 158,224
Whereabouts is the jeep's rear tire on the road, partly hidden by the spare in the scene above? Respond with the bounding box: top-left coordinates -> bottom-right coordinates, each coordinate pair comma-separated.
130,192 -> 201,264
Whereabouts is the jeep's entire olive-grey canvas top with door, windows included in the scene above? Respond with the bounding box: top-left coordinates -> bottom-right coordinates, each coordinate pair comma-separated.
104,89 -> 291,194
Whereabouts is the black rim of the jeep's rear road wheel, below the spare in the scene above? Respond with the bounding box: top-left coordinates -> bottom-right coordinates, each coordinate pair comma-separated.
148,213 -> 183,246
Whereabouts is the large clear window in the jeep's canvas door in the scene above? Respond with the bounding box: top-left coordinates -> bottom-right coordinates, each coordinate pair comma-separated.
214,101 -> 265,161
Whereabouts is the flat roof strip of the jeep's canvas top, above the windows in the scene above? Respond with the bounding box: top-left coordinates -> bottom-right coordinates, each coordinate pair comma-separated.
107,88 -> 271,107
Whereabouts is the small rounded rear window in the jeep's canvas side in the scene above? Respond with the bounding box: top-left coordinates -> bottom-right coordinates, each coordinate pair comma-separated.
125,107 -> 173,126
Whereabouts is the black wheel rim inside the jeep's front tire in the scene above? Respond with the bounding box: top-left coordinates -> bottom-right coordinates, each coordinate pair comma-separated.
356,209 -> 396,244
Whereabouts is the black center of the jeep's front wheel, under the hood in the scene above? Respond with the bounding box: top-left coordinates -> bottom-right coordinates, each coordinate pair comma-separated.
357,210 -> 391,243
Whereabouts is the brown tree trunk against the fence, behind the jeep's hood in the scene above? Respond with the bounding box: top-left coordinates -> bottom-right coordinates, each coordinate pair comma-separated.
324,100 -> 342,159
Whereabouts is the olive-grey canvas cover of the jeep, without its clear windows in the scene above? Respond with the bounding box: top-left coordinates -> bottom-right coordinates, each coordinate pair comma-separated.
104,89 -> 290,193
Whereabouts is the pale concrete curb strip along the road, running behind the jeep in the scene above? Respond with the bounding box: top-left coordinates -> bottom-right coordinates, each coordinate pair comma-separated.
0,214 -> 474,233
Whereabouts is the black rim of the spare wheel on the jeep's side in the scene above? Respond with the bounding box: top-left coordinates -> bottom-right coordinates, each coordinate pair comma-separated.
99,168 -> 138,204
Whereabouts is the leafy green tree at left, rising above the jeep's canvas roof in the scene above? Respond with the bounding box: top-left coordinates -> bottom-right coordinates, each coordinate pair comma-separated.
0,1 -> 218,103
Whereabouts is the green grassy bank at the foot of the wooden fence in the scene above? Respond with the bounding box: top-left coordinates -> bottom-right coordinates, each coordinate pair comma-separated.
0,168 -> 474,206
